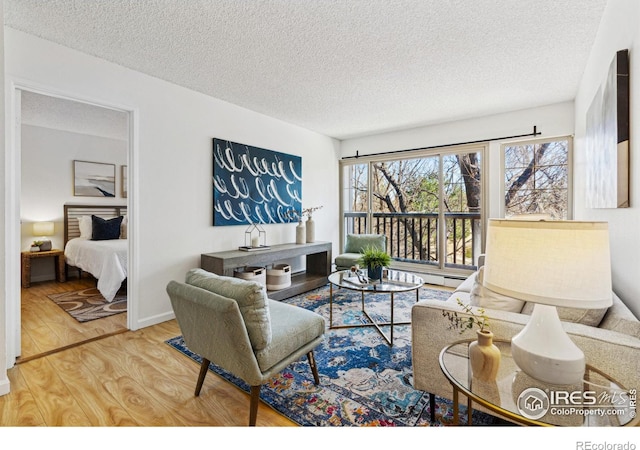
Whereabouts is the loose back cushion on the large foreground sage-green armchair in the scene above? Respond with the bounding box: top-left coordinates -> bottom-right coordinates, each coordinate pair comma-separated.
186,269 -> 272,350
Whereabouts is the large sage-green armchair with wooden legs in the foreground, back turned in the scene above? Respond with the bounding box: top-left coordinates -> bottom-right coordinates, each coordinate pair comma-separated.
166,269 -> 325,426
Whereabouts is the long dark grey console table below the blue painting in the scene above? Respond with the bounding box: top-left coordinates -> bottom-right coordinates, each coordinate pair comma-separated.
200,242 -> 332,300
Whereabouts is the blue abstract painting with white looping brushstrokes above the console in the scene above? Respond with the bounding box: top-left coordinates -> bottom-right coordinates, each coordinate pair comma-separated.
213,138 -> 302,226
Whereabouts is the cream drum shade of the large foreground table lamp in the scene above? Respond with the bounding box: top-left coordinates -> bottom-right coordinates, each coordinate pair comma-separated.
483,219 -> 613,309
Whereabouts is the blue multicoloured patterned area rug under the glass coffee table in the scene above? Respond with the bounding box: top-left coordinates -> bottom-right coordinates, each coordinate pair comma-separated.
167,285 -> 505,427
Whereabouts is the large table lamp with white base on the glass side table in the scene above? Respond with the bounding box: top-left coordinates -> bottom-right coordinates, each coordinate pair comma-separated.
483,219 -> 612,384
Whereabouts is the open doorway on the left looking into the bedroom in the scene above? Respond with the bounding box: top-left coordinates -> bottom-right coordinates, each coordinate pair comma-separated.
14,88 -> 132,363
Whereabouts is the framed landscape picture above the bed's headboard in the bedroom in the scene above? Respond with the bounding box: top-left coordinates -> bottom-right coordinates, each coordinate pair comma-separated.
73,160 -> 116,197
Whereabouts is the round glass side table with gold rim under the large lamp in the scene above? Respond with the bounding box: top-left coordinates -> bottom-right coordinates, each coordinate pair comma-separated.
439,339 -> 638,427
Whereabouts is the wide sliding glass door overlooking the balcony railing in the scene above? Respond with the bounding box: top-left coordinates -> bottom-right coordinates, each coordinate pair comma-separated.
341,146 -> 484,270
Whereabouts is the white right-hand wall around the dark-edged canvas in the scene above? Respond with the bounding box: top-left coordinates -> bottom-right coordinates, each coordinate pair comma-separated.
574,0 -> 640,317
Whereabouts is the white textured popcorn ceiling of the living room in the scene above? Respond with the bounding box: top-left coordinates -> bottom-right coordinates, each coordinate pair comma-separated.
4,0 -> 606,139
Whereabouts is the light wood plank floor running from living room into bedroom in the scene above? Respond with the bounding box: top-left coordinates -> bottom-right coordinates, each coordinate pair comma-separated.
0,281 -> 296,427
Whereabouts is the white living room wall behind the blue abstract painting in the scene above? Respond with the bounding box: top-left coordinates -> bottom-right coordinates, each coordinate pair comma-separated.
5,28 -> 339,342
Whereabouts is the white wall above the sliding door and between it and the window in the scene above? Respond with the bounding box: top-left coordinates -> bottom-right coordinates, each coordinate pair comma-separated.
340,102 -> 574,221
